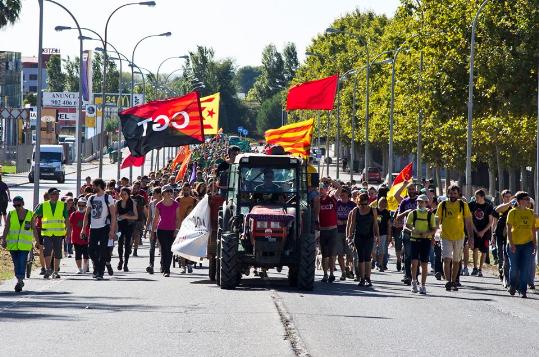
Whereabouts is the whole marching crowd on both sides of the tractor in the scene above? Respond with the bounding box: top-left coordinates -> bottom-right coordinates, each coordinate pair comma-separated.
0,138 -> 537,298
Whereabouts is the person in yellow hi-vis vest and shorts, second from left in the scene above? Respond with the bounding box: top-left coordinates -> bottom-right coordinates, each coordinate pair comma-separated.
34,187 -> 70,279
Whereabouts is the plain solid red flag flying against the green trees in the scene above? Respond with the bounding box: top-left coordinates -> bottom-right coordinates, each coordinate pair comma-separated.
286,75 -> 339,110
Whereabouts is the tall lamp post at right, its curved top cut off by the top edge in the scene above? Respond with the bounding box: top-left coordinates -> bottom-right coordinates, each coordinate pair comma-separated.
466,0 -> 489,197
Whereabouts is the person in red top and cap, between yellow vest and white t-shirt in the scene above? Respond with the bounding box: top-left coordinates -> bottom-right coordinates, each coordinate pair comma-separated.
69,197 -> 90,274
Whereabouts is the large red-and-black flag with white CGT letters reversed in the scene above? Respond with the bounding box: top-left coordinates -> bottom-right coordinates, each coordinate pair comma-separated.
119,92 -> 204,156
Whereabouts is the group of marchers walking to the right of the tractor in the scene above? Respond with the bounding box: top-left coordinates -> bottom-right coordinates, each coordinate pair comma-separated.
309,177 -> 538,298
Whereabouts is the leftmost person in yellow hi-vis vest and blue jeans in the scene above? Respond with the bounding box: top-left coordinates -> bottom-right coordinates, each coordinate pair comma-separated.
0,196 -> 39,292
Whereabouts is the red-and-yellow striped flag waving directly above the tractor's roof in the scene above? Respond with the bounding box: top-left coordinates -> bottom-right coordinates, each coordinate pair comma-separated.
264,119 -> 314,158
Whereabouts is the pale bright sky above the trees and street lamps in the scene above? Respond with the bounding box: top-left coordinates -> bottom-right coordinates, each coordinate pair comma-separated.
0,0 -> 399,73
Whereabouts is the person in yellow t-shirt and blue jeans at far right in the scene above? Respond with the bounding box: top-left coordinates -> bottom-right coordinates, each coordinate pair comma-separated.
506,191 -> 537,298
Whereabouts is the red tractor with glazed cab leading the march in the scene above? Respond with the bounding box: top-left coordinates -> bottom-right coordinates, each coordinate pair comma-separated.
215,154 -> 316,290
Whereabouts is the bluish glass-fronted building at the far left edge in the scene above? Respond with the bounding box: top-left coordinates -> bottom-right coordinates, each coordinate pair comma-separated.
0,51 -> 22,108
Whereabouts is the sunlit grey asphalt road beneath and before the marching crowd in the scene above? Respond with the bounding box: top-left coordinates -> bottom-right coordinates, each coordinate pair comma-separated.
0,154 -> 539,356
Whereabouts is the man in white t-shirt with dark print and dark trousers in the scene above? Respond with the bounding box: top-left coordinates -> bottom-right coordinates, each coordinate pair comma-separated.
82,178 -> 117,280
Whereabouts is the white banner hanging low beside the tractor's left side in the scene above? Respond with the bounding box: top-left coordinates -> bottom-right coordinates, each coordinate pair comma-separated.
172,195 -> 211,261
